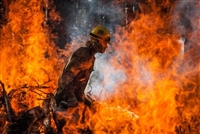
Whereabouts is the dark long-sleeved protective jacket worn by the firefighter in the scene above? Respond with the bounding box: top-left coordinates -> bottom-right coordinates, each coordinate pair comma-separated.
55,40 -> 100,105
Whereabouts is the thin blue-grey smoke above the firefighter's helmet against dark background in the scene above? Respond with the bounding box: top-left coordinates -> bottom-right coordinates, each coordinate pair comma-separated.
65,0 -> 124,40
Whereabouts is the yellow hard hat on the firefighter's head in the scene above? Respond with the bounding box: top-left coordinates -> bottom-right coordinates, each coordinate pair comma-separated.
90,26 -> 110,44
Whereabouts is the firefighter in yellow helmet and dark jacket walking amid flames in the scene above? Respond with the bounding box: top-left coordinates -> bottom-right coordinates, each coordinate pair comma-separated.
55,26 -> 110,108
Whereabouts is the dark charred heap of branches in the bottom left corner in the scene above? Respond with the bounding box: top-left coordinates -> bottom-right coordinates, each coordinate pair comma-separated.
0,81 -> 56,134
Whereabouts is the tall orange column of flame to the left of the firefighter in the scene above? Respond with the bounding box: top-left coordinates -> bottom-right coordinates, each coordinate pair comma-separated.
0,0 -> 62,111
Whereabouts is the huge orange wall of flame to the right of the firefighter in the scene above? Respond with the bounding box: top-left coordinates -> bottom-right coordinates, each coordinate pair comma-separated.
79,1 -> 200,134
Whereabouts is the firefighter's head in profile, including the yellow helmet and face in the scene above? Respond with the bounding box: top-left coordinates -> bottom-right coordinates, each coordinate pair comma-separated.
90,26 -> 111,53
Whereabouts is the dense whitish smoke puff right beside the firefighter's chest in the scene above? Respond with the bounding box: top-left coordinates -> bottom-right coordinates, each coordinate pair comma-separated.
86,53 -> 126,100
